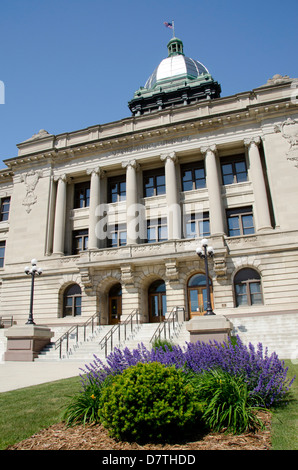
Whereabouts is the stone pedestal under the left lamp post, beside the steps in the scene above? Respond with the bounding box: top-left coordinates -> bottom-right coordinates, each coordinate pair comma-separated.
4,324 -> 54,362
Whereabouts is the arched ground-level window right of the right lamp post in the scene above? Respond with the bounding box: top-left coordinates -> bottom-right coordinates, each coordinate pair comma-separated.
234,268 -> 263,307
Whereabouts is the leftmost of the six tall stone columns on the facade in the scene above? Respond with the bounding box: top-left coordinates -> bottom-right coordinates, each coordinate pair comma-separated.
53,175 -> 67,255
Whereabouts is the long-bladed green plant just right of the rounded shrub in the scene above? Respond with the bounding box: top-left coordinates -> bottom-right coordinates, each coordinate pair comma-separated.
190,369 -> 262,434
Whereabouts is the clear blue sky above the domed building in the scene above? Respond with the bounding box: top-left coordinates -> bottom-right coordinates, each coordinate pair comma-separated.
0,0 -> 298,168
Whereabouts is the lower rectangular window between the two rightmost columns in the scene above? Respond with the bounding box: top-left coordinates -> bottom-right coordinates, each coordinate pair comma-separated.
227,207 -> 255,237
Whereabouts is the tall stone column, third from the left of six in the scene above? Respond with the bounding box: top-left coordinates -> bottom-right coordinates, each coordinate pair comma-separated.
122,160 -> 141,245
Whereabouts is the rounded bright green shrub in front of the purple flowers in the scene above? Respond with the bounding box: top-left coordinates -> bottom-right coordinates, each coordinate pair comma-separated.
99,362 -> 202,441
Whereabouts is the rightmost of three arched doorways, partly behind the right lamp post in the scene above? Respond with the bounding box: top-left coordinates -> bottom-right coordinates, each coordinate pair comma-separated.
187,273 -> 213,318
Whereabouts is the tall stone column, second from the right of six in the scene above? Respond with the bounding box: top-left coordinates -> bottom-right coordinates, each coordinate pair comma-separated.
201,145 -> 225,235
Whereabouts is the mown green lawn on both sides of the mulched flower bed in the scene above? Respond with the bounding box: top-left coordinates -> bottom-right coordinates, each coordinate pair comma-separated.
0,360 -> 298,450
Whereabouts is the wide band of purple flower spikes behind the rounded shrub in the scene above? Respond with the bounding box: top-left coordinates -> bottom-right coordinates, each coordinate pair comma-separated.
81,336 -> 295,408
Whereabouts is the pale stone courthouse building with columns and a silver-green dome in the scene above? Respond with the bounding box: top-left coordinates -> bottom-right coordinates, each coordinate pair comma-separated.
0,38 -> 298,326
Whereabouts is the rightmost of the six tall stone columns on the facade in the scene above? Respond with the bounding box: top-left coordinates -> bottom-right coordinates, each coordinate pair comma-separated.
244,137 -> 272,232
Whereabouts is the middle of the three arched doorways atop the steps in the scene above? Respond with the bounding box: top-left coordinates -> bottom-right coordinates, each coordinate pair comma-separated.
148,280 -> 167,323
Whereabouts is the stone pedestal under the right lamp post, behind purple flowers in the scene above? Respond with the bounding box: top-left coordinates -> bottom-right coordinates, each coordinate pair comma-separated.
186,315 -> 233,343
